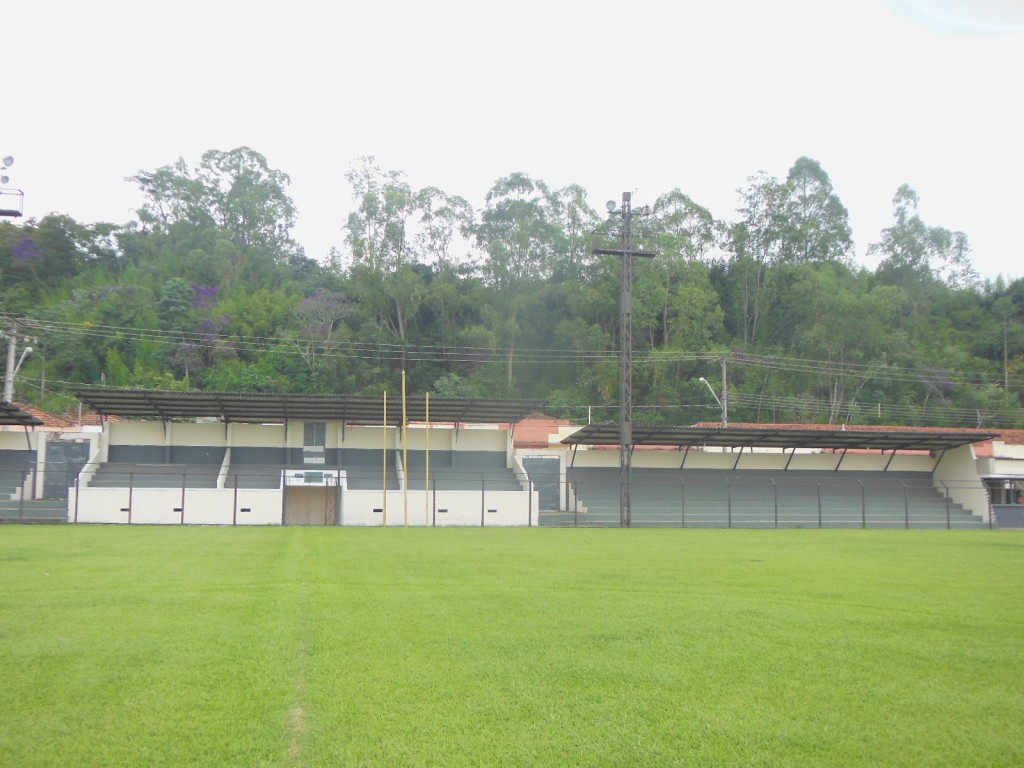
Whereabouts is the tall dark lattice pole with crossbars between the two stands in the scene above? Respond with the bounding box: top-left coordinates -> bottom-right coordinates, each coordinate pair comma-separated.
594,191 -> 654,528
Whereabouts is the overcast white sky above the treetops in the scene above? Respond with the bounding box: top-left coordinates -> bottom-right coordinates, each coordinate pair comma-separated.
8,0 -> 1024,278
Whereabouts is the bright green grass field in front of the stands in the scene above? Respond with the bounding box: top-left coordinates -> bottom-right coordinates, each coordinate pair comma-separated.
0,525 -> 1024,768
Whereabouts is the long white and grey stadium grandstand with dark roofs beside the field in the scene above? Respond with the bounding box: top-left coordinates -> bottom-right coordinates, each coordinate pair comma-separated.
0,387 -> 1024,528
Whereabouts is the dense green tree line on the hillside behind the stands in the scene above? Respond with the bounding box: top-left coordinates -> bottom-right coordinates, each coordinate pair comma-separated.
0,147 -> 1024,426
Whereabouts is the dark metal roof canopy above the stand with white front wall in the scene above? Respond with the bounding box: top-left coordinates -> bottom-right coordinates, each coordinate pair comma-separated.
74,387 -> 541,426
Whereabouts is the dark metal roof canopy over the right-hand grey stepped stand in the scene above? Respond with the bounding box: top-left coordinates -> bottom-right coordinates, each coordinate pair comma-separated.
562,422 -> 999,452
